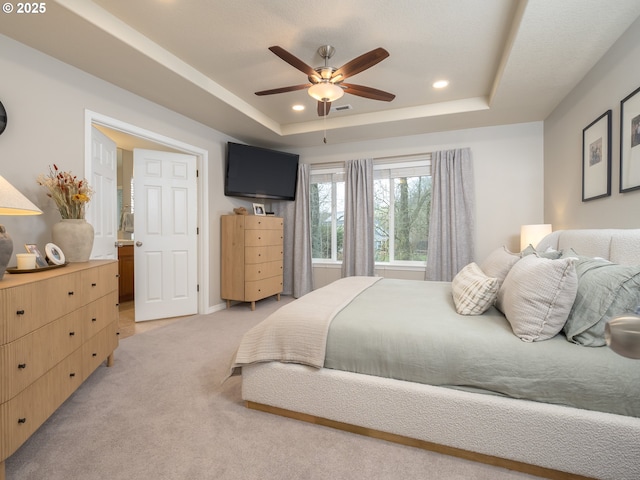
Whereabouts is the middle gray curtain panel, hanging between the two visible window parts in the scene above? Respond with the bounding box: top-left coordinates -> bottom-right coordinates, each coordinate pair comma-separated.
342,158 -> 375,277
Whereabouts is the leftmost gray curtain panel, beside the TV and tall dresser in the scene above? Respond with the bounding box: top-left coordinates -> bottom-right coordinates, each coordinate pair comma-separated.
273,163 -> 313,298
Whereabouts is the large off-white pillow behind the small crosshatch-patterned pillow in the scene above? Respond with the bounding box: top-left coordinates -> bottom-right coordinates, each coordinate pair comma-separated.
498,255 -> 578,342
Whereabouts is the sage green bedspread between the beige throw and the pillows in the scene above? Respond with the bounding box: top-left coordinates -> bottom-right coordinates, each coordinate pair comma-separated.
324,279 -> 640,417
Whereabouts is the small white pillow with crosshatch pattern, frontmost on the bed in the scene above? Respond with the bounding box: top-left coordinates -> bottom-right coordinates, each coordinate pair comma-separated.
451,263 -> 500,315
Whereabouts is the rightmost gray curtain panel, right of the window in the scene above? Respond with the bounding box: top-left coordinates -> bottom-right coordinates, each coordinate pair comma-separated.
425,148 -> 476,282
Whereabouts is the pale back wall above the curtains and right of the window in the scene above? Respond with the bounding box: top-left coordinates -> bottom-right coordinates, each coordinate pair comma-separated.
297,122 -> 543,261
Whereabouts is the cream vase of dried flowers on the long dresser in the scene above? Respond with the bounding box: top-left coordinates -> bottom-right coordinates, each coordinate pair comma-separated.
37,164 -> 94,262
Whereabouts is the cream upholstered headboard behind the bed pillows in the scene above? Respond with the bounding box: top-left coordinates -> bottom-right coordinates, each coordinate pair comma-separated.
536,228 -> 640,265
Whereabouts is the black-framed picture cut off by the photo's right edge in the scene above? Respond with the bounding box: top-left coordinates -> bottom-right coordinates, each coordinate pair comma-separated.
620,87 -> 640,193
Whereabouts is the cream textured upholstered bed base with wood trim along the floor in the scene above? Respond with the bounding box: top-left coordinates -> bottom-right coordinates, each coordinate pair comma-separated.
242,362 -> 640,480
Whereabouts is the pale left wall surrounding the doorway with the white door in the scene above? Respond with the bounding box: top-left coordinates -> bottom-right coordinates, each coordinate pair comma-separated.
0,35 -> 250,312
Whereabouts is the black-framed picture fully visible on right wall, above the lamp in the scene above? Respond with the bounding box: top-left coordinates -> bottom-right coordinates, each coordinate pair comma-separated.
582,110 -> 611,202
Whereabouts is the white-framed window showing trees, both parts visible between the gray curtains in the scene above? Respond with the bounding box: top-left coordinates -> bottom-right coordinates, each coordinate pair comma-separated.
310,155 -> 431,265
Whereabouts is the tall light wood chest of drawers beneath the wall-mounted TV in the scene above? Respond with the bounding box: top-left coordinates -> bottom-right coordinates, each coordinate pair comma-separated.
220,215 -> 284,310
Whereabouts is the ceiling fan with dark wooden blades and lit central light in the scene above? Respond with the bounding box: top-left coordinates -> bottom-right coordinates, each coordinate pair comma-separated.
256,45 -> 395,117
